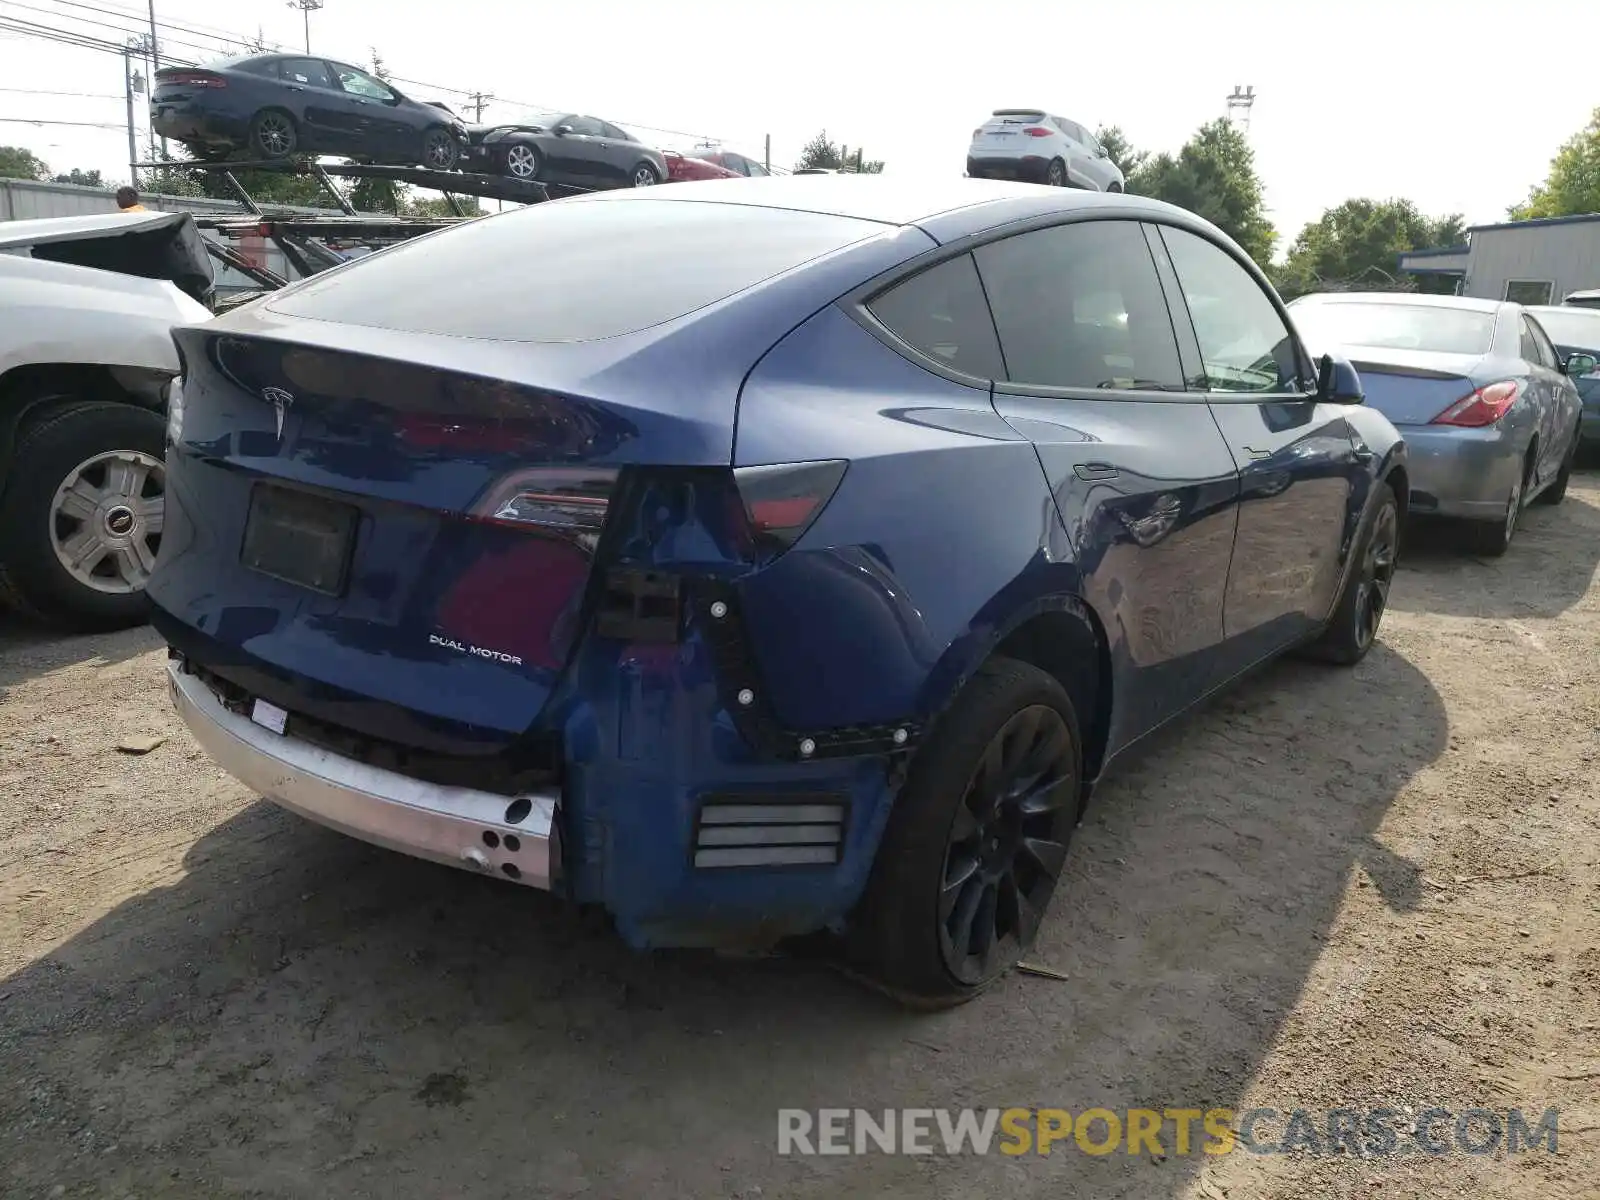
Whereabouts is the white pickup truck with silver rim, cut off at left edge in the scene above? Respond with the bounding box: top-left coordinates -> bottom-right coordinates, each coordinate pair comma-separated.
0,213 -> 214,629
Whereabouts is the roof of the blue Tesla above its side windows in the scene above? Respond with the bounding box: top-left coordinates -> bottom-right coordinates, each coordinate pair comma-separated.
558,173 -> 1197,242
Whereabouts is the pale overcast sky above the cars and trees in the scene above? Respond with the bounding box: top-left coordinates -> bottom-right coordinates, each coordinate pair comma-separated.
0,0 -> 1600,253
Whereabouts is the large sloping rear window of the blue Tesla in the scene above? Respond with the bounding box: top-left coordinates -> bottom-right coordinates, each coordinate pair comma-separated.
267,195 -> 885,342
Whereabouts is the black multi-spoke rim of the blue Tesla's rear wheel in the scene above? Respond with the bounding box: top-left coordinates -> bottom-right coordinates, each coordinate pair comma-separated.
938,704 -> 1077,984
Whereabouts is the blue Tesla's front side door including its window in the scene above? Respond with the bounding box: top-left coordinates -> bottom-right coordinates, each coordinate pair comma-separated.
1152,226 -> 1368,659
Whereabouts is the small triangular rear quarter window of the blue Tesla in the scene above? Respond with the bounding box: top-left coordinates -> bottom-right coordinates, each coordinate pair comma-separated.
867,254 -> 1005,379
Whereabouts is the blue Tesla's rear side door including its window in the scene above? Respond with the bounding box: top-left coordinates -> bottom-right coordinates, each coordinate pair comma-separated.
973,221 -> 1238,754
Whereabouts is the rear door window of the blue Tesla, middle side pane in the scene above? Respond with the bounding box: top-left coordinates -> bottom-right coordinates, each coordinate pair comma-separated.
974,221 -> 1184,392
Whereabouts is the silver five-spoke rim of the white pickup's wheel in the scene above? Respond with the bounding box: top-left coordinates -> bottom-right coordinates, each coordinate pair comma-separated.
50,450 -> 166,595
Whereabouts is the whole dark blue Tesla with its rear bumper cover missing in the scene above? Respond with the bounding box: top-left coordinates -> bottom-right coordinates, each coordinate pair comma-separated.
150,176 -> 1408,1005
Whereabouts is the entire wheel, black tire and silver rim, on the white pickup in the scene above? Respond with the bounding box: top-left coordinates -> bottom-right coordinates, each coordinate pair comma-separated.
0,400 -> 166,630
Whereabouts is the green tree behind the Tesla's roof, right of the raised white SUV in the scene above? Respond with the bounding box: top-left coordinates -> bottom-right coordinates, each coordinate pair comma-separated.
1128,117 -> 1277,262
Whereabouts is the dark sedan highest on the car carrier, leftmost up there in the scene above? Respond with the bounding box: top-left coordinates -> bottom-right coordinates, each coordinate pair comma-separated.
150,54 -> 467,171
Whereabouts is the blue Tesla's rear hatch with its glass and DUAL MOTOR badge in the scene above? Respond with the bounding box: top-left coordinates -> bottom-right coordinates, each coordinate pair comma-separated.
150,194 -> 926,739
